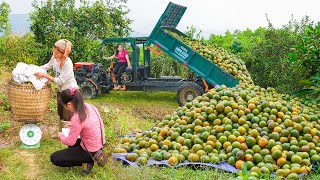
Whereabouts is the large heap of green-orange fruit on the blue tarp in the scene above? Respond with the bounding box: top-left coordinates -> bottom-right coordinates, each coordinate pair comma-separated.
114,85 -> 320,177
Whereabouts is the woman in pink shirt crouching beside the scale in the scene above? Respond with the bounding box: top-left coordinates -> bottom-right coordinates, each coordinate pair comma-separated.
51,88 -> 105,175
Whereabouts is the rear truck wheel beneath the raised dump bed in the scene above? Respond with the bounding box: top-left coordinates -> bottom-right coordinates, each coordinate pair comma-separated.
177,83 -> 204,106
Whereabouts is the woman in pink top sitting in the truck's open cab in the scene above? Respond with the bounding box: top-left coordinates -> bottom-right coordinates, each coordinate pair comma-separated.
105,44 -> 132,90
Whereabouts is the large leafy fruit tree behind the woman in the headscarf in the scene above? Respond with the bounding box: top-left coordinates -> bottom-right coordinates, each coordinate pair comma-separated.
30,0 -> 131,64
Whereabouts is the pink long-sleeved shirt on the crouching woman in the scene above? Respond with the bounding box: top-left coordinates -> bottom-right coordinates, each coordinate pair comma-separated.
58,103 -> 105,152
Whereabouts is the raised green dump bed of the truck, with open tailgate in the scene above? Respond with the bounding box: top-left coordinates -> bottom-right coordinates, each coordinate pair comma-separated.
146,2 -> 239,87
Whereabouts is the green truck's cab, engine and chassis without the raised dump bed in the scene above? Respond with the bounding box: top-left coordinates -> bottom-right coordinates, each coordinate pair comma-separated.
74,37 -> 212,105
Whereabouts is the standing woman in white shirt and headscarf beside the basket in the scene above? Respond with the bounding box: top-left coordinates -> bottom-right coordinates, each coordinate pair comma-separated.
35,39 -> 78,121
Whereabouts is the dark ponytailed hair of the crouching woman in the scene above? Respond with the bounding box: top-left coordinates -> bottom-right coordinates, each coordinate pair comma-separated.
58,89 -> 87,122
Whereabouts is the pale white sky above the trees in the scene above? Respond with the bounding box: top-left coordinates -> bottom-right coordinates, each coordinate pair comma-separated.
0,0 -> 320,36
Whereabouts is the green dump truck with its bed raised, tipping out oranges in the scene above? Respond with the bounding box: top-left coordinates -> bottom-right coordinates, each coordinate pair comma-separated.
74,2 -> 239,106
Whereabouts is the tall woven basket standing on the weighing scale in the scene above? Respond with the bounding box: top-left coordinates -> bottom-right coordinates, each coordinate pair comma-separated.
8,80 -> 51,122
